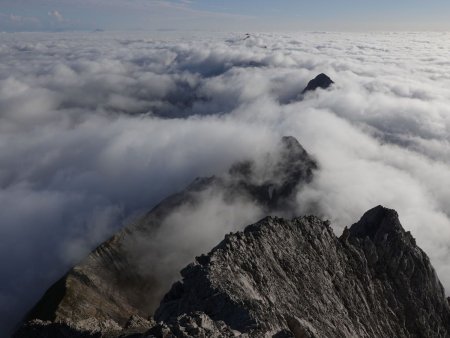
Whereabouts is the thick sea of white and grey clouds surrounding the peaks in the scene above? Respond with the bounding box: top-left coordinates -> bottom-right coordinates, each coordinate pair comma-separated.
0,33 -> 450,331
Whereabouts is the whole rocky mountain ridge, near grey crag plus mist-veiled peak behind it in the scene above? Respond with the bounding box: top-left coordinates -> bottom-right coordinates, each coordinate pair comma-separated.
14,117 -> 450,338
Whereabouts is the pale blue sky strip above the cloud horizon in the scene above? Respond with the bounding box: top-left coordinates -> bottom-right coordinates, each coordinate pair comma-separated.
0,0 -> 450,32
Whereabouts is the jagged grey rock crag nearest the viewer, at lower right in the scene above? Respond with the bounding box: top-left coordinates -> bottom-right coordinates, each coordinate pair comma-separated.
155,207 -> 450,337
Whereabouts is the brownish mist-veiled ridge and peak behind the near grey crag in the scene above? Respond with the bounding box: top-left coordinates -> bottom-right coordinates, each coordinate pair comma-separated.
14,137 -> 317,336
